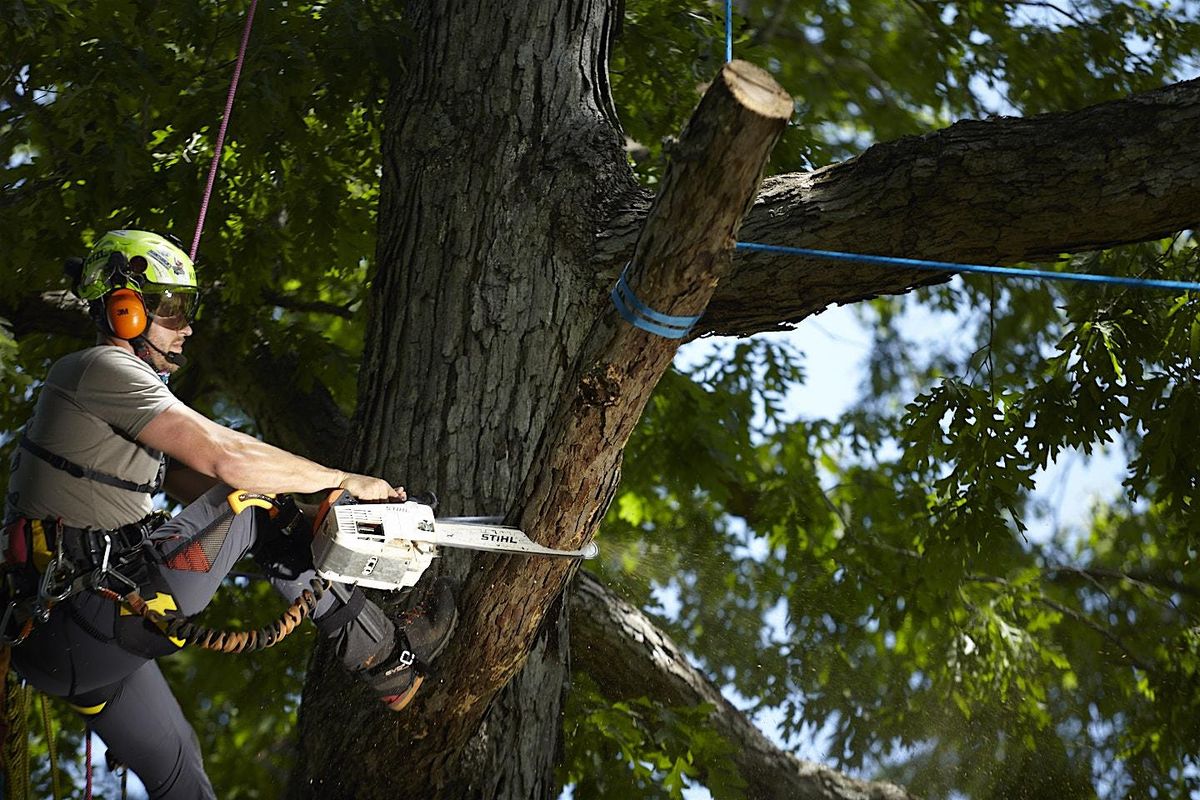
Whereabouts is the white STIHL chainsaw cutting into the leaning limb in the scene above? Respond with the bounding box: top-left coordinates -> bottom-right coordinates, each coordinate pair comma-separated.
312,500 -> 599,589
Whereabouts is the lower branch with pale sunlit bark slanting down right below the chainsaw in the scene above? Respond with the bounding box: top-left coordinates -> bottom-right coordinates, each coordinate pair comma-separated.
570,572 -> 912,800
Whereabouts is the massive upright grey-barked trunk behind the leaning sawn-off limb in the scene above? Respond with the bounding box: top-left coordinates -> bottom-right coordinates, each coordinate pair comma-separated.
292,0 -> 637,800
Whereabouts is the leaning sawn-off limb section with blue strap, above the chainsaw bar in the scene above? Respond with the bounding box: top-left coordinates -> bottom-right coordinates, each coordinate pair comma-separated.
520,61 -> 792,548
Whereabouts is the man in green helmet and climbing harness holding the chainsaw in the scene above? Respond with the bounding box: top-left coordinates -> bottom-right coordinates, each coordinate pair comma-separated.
5,230 -> 456,798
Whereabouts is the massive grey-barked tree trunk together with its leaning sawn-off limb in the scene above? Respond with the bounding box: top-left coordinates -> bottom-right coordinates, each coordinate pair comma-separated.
286,0 -> 816,800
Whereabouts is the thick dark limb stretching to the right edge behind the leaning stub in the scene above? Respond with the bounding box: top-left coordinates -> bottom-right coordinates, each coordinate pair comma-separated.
601,79 -> 1200,336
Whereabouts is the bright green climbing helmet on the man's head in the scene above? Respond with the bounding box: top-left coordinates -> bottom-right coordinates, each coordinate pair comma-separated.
77,230 -> 199,326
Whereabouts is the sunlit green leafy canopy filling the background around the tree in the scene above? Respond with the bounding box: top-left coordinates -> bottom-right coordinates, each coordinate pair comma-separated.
0,0 -> 1200,798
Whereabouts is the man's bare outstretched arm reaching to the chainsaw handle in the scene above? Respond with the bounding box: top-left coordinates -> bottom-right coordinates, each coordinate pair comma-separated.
137,404 -> 404,500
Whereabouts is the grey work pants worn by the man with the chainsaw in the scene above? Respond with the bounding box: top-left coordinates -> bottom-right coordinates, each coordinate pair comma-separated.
12,486 -> 395,800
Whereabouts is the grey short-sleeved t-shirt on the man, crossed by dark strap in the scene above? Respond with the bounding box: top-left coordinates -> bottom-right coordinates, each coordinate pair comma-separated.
5,344 -> 181,529
